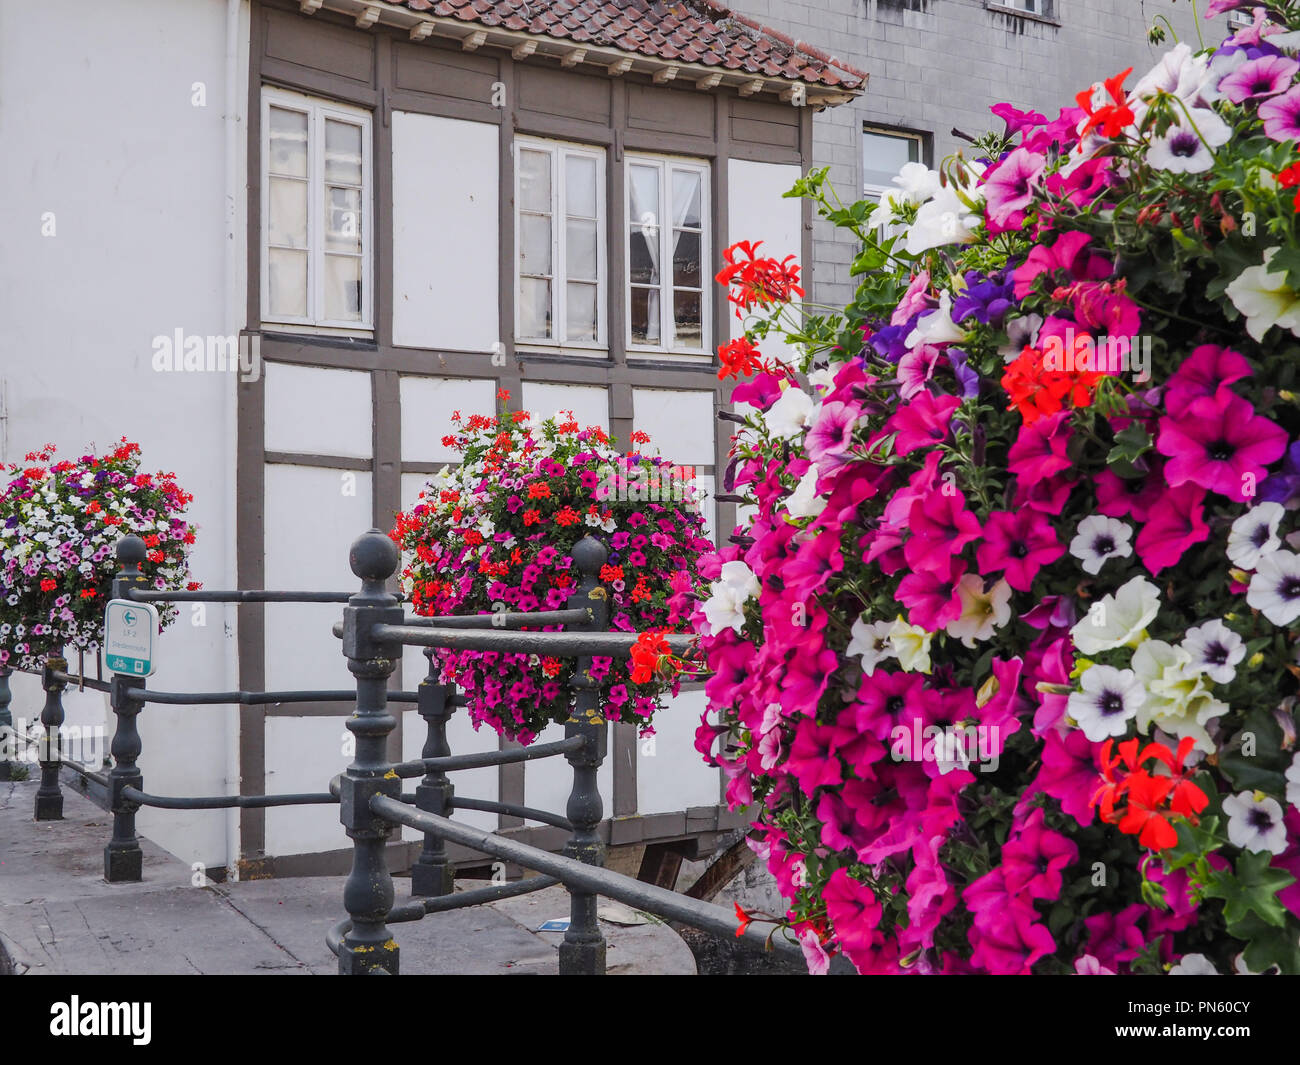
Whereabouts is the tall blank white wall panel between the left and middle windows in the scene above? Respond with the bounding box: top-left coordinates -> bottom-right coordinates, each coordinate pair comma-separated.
393,111 -> 503,351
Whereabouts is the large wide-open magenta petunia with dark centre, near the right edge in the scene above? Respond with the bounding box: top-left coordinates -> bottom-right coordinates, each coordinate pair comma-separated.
1156,389 -> 1287,503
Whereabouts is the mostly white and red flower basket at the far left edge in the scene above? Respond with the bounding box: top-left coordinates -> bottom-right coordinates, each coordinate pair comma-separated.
0,437 -> 199,668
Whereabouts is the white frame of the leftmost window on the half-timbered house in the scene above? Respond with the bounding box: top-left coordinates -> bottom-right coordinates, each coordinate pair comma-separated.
259,86 -> 376,335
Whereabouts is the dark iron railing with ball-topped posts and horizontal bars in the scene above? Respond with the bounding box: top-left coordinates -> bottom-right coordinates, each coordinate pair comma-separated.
0,529 -> 798,975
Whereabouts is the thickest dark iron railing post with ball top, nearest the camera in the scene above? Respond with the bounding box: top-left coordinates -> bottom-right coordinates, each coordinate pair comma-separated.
338,529 -> 403,975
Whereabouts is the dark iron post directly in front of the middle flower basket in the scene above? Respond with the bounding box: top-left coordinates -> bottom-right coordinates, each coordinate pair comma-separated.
560,536 -> 610,977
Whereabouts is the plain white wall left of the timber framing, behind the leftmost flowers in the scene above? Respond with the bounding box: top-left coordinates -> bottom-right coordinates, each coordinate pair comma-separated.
0,0 -> 248,865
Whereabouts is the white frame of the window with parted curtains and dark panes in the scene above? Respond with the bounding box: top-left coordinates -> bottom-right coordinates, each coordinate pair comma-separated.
620,152 -> 714,360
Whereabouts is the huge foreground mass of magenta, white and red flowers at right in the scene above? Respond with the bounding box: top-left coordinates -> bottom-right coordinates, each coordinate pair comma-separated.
696,3 -> 1300,973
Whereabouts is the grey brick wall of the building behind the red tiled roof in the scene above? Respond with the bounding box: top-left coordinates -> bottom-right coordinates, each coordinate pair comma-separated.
732,0 -> 1227,306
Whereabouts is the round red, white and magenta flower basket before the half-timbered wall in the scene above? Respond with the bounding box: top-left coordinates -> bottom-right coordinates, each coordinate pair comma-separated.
391,393 -> 712,744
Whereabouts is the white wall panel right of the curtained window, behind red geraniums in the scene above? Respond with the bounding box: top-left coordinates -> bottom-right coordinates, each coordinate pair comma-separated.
727,159 -> 807,360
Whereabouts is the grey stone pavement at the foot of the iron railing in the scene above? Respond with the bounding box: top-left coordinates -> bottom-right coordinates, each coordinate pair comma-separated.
0,780 -> 696,975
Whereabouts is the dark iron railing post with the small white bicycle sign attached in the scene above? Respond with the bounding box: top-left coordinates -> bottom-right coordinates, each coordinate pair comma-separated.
104,536 -> 148,884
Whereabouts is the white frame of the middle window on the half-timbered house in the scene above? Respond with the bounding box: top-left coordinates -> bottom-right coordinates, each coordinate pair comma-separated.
512,137 -> 610,354
